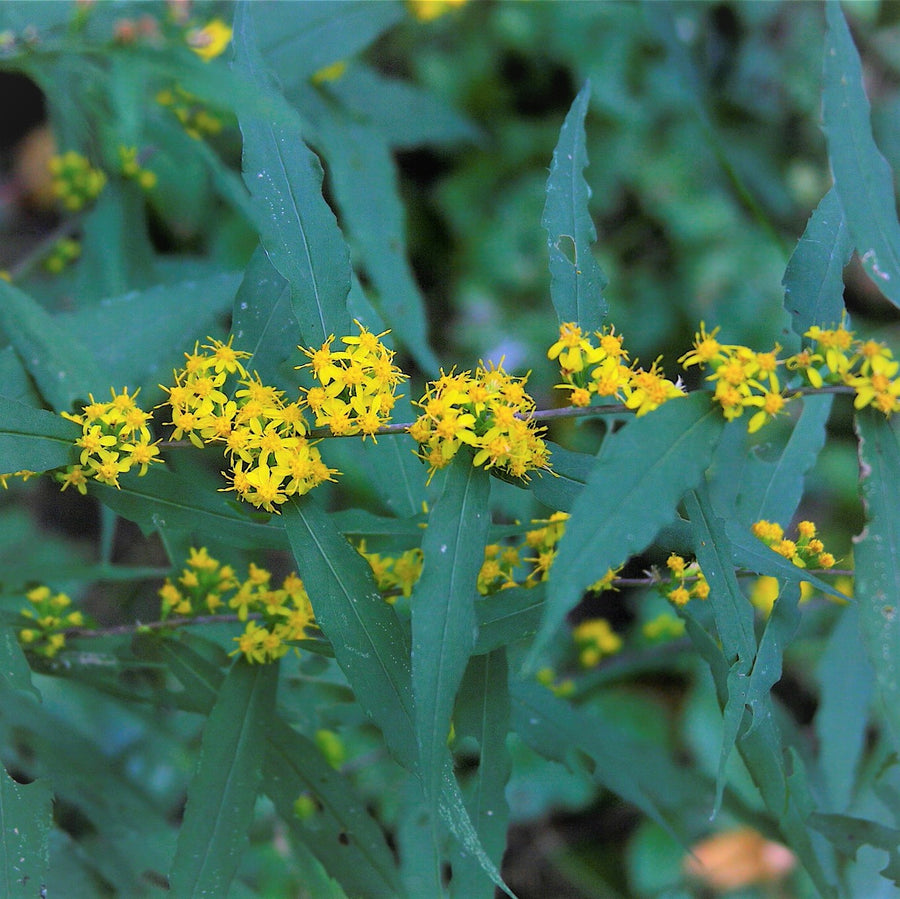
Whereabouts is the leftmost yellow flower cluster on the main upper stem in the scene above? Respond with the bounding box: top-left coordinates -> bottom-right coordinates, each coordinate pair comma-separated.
56,387 -> 161,493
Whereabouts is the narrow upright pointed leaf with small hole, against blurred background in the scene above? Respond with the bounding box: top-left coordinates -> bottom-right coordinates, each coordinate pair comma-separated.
541,82 -> 608,331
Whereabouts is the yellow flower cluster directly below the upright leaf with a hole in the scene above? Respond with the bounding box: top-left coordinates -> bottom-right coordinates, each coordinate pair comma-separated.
547,322 -> 684,416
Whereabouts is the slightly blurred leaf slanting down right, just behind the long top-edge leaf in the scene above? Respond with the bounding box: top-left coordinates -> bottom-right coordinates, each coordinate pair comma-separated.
302,102 -> 439,375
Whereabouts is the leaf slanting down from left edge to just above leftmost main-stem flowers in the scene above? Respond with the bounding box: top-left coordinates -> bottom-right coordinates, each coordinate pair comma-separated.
0,280 -> 105,412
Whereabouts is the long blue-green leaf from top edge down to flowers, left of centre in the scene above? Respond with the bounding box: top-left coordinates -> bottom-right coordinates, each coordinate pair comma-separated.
234,4 -> 350,346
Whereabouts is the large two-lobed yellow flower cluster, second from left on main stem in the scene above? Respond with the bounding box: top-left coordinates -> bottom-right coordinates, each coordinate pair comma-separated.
163,339 -> 336,512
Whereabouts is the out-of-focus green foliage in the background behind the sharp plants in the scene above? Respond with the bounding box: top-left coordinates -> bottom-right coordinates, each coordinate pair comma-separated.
0,0 -> 900,899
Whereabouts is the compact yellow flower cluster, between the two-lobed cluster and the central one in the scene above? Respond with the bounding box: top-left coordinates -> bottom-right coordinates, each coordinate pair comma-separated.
298,321 -> 407,440
